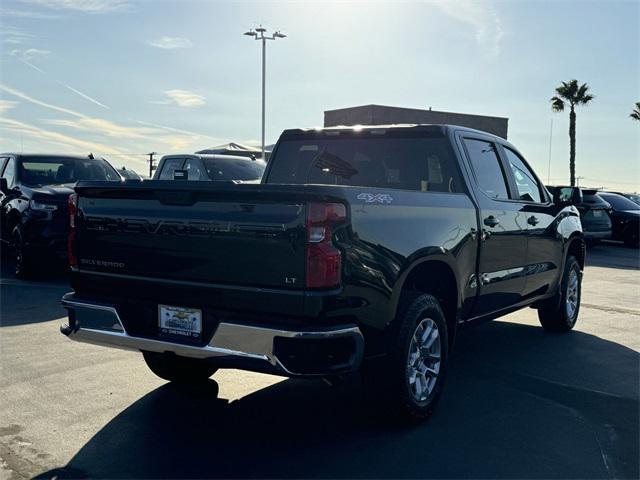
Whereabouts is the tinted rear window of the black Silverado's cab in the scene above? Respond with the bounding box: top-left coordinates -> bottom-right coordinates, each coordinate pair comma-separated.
268,137 -> 461,192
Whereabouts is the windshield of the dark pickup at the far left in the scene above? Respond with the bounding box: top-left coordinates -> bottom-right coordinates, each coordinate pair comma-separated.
18,157 -> 120,187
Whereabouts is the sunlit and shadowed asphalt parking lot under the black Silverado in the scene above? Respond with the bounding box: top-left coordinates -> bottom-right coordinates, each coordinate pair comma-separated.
0,244 -> 640,479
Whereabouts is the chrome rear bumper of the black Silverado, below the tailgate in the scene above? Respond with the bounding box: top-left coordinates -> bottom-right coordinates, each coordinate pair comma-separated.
60,293 -> 364,376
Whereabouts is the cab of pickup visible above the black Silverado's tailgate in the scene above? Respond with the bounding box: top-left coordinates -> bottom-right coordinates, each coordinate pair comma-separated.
153,154 -> 266,183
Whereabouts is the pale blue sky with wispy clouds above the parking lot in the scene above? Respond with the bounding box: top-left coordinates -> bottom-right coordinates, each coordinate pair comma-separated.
0,0 -> 640,191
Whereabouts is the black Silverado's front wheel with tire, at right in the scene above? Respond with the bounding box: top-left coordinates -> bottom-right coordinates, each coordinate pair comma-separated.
538,256 -> 582,333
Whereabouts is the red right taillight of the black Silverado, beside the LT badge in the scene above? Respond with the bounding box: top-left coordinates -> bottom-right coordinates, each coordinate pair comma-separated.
306,203 -> 347,288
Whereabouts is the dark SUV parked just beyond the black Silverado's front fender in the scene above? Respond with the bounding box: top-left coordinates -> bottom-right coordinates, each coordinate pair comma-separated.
547,186 -> 611,245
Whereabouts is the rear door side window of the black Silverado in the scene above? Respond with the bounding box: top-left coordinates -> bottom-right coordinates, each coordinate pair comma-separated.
464,138 -> 509,200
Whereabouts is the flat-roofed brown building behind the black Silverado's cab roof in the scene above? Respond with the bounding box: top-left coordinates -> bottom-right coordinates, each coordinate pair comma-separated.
324,105 -> 509,139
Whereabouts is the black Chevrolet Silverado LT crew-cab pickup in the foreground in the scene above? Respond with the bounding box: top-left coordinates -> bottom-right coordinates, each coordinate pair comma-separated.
62,125 -> 585,419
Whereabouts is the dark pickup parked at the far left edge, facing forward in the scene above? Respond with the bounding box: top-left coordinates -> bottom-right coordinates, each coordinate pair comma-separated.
0,153 -> 121,278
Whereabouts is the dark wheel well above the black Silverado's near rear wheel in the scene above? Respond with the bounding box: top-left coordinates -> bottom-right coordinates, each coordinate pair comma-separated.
398,260 -> 458,345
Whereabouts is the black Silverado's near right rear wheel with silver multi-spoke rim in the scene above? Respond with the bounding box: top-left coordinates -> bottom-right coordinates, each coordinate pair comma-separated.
364,294 -> 449,422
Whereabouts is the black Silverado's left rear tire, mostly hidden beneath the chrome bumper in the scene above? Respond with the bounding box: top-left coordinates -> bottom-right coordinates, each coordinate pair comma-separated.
142,352 -> 217,384
